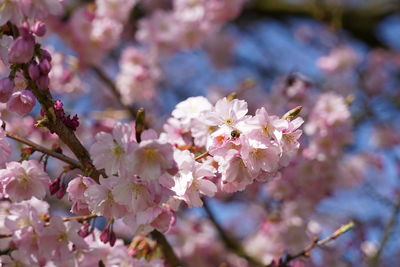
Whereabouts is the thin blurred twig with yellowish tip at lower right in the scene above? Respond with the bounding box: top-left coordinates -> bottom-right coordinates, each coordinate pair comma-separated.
279,221 -> 354,266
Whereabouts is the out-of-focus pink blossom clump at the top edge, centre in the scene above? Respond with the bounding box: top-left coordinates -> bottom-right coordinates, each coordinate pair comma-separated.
136,0 -> 244,54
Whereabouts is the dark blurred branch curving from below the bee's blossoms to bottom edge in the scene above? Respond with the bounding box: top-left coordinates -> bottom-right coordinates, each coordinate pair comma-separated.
203,199 -> 265,266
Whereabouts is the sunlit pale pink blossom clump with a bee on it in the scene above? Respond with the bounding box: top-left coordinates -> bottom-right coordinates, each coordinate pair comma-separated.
162,97 -> 303,192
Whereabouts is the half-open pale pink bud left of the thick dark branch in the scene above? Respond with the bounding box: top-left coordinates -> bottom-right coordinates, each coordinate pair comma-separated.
7,90 -> 36,115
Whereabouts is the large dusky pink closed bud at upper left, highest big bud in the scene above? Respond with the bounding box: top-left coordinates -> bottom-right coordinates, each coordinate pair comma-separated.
8,35 -> 35,63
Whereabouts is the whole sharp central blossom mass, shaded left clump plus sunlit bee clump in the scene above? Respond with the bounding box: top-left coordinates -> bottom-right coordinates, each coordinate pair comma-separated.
78,97 -> 302,236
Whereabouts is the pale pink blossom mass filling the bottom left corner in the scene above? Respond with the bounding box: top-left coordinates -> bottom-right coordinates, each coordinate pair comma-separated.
0,197 -> 164,267
